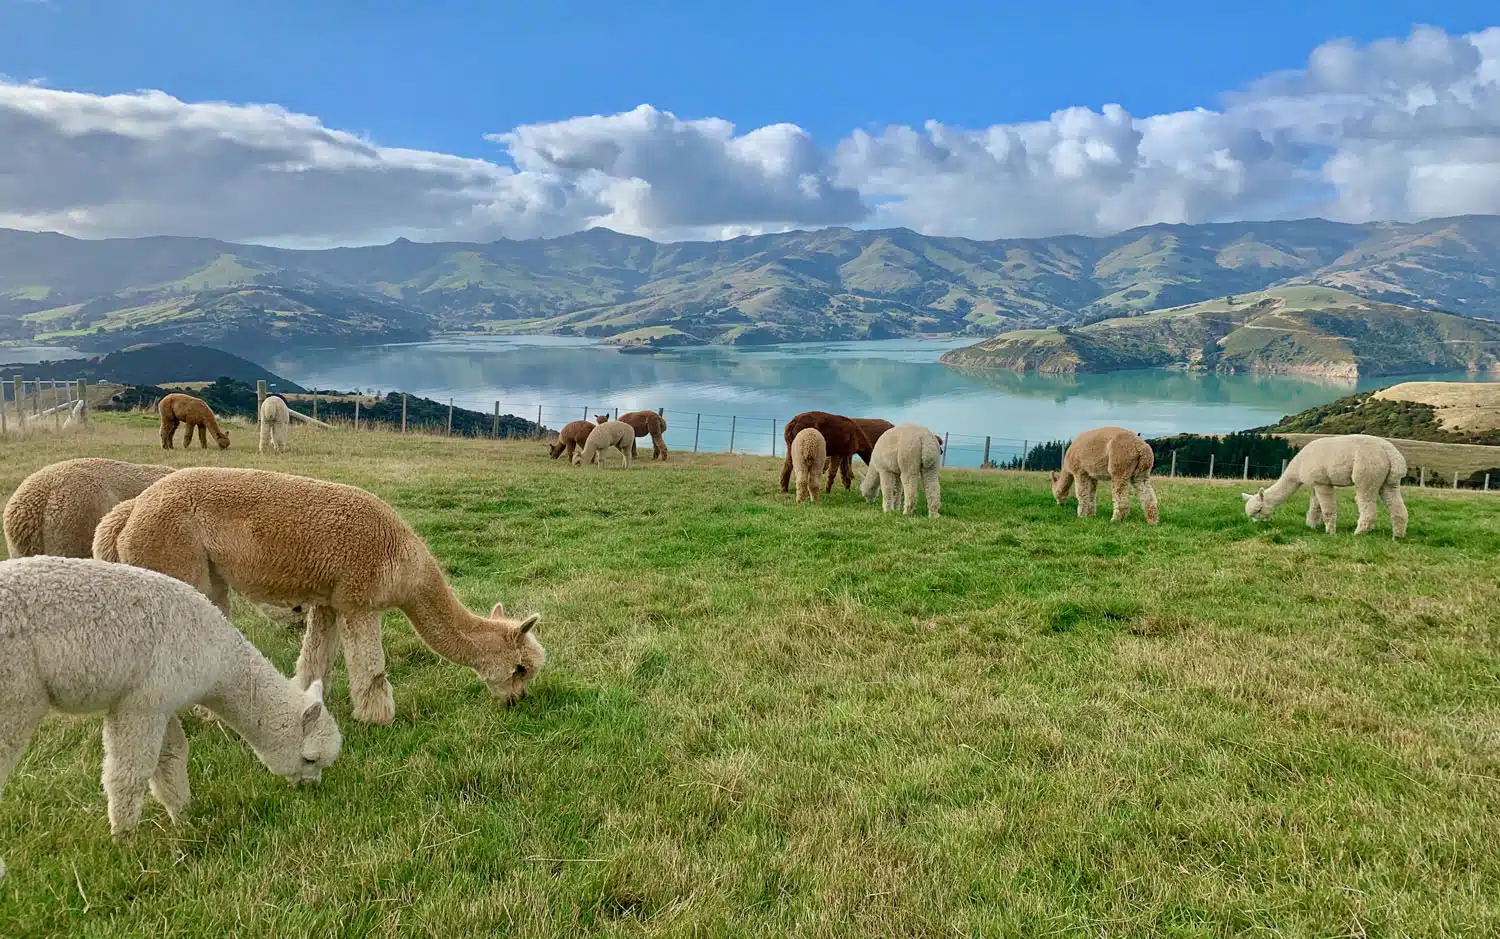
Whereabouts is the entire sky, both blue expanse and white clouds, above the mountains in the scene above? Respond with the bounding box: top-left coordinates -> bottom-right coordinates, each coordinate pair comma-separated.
0,0 -> 1500,245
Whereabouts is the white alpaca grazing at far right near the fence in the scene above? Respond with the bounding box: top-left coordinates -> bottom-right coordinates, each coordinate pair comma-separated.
1241,434 -> 1407,539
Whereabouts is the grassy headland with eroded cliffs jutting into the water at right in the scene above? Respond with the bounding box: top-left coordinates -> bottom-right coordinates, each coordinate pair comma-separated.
942,287 -> 1500,378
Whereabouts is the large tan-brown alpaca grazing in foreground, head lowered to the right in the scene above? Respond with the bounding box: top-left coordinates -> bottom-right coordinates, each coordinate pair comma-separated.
93,467 -> 546,725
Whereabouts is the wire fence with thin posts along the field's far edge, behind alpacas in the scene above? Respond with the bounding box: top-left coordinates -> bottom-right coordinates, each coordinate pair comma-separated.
288,384 -> 1500,492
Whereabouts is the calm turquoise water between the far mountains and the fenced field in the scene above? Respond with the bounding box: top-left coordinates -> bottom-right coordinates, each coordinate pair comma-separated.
266,336 -> 1464,462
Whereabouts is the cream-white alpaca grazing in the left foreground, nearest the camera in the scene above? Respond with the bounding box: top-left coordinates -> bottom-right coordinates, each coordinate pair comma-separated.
0,558 -> 342,873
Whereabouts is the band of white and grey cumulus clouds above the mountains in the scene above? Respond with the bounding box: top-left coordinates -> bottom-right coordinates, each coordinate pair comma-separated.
0,27 -> 1500,245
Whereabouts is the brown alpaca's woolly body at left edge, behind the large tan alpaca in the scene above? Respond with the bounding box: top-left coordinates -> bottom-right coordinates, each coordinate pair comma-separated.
5,458 -> 173,558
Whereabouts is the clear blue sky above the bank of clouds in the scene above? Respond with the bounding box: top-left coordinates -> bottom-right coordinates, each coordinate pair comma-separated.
0,0 -> 1500,156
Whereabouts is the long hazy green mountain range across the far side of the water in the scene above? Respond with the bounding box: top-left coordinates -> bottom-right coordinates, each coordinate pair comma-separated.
0,216 -> 1500,351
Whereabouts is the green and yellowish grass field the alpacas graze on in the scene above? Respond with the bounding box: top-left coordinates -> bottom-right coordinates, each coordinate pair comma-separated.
0,416 -> 1500,939
